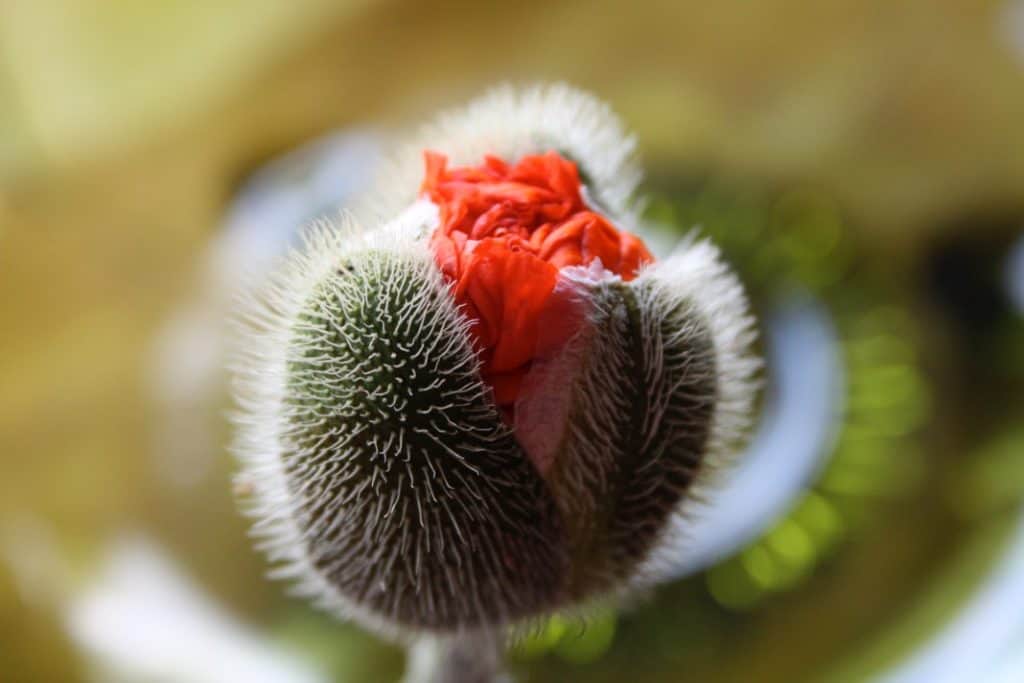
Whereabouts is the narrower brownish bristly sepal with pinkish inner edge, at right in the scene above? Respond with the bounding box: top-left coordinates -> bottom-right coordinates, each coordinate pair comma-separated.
516,236 -> 758,602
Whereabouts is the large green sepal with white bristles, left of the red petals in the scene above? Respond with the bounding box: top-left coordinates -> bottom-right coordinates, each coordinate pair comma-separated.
230,212 -> 567,636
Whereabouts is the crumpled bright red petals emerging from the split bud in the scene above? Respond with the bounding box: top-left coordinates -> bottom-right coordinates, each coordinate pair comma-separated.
421,152 -> 653,420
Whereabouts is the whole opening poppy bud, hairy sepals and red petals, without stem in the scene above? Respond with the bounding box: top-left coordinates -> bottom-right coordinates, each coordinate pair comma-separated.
234,86 -> 759,659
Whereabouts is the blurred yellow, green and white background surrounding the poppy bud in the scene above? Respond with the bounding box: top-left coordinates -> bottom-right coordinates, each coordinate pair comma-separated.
0,0 -> 1024,683
